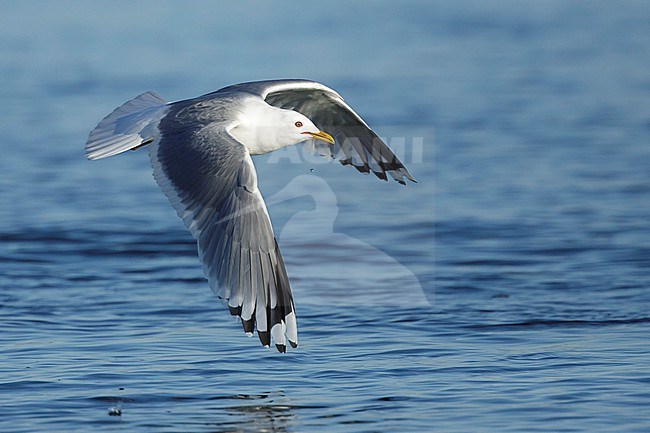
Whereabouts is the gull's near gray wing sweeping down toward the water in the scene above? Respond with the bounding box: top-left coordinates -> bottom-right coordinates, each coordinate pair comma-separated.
149,106 -> 298,352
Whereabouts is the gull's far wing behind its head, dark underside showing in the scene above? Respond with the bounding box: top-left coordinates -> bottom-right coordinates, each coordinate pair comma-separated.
219,80 -> 415,184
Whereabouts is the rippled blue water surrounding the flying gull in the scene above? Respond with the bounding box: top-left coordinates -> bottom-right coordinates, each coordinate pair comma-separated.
0,0 -> 650,432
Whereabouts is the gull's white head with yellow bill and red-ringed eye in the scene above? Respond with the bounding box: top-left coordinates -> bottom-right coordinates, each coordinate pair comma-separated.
230,102 -> 334,155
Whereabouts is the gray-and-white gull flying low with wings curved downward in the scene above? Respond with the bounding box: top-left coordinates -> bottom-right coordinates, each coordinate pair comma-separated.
85,80 -> 415,352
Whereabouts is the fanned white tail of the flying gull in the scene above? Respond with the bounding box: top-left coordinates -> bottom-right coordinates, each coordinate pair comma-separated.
86,92 -> 168,159
